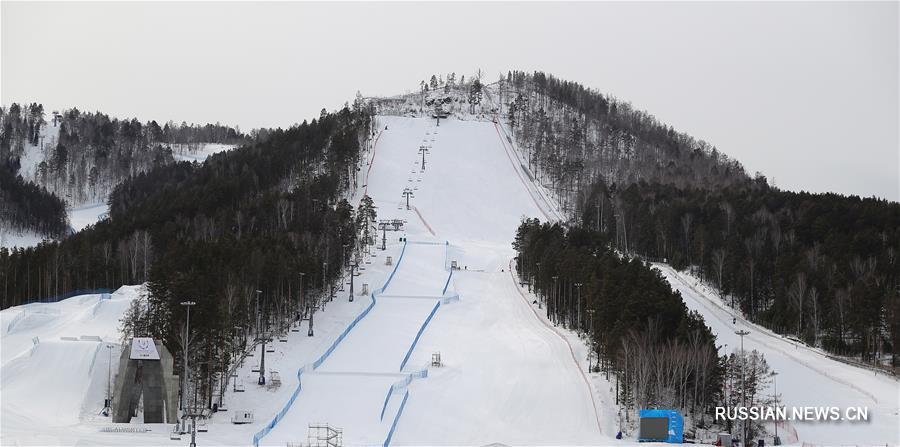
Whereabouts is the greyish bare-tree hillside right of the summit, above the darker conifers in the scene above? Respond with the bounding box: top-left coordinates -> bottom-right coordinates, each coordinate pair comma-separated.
502,71 -> 748,218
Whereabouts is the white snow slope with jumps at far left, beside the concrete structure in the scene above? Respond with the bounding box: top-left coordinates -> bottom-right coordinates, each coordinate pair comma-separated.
0,286 -> 141,445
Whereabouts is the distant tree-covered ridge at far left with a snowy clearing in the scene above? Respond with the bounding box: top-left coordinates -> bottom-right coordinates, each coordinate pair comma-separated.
0,103 -> 251,206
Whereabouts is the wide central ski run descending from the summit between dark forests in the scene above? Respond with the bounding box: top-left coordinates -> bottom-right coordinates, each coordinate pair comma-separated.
278,117 -> 614,445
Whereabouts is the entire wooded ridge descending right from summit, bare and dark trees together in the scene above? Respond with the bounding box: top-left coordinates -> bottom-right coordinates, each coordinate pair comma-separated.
497,72 -> 900,372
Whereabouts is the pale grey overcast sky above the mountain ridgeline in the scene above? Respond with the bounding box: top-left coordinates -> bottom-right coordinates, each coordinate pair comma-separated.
0,1 -> 900,201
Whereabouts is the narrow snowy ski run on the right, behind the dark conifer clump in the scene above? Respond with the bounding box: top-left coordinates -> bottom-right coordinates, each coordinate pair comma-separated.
654,264 -> 900,445
